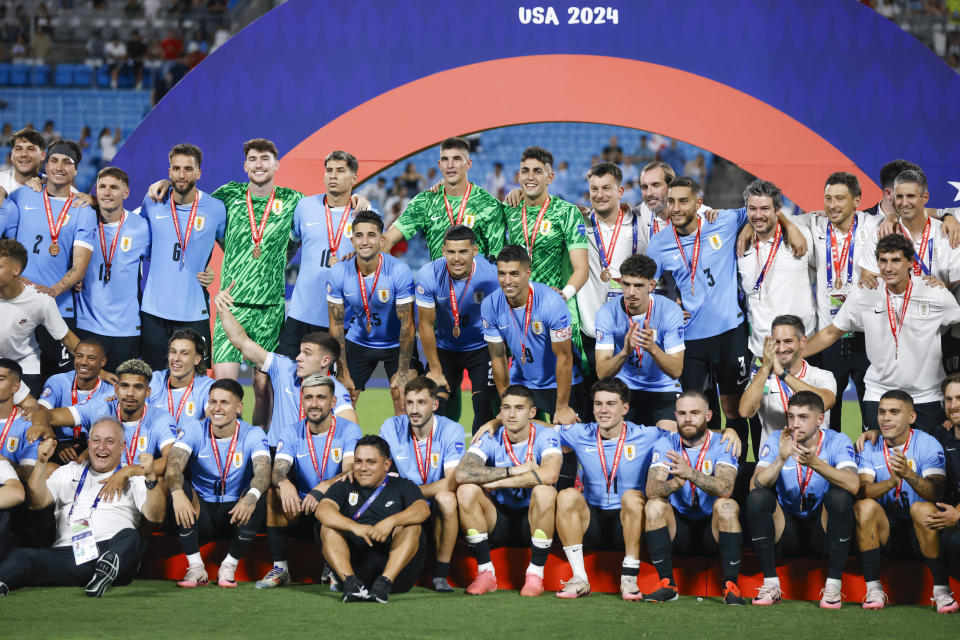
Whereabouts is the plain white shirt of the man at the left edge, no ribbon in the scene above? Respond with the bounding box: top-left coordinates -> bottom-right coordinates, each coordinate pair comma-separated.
0,286 -> 68,375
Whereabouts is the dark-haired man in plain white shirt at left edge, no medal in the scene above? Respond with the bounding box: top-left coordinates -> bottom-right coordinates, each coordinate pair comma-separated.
0,239 -> 78,397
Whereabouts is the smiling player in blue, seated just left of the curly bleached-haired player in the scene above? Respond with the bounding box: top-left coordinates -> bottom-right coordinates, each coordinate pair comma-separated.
39,338 -> 116,464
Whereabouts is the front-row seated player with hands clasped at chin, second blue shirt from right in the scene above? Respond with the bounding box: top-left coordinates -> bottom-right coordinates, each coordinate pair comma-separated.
747,391 -> 859,609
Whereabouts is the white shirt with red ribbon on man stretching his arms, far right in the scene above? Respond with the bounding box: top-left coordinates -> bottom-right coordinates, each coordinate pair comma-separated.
833,276 -> 960,403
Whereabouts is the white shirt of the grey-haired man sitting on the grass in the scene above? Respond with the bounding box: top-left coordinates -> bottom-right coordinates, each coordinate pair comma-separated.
47,462 -> 147,547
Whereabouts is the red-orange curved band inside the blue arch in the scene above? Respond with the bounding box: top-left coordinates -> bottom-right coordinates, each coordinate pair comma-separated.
277,55 -> 880,210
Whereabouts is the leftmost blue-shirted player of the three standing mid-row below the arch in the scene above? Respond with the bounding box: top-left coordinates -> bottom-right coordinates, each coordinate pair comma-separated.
327,211 -> 416,414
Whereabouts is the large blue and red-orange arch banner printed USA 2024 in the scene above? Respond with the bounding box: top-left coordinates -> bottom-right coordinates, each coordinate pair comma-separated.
116,0 -> 960,215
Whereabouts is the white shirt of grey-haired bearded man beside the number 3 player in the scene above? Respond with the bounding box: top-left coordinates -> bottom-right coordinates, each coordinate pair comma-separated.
737,227 -> 817,356
